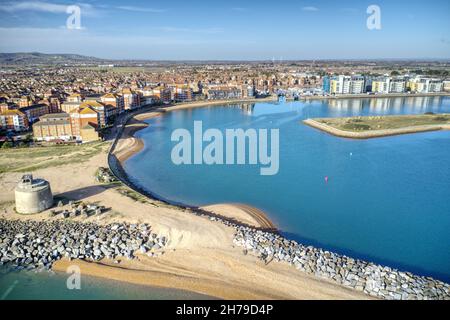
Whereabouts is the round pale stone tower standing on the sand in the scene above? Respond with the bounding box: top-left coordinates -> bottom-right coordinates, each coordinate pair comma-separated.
15,174 -> 53,214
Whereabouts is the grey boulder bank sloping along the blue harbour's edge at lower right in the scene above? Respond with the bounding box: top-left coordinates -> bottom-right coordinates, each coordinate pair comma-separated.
234,226 -> 450,300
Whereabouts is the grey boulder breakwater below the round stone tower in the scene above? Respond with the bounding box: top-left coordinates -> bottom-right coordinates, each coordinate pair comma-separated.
0,219 -> 167,270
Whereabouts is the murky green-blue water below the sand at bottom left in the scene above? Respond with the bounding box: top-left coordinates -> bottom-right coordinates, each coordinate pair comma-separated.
0,268 -> 210,300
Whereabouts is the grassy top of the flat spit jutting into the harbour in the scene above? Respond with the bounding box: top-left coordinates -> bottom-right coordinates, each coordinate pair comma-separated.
313,114 -> 450,132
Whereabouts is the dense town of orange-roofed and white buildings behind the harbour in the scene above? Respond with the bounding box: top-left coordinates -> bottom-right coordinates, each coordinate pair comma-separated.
0,61 -> 450,140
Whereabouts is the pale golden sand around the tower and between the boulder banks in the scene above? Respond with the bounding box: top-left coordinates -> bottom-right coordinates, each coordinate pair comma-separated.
0,152 -> 369,299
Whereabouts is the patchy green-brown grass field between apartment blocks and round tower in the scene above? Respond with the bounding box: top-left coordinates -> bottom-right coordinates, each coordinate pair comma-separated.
0,142 -> 109,173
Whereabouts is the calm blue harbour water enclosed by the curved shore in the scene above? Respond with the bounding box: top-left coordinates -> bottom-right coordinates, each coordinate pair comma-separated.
125,97 -> 450,282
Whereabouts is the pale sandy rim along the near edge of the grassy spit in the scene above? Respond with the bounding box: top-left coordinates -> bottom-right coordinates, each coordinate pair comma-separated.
303,119 -> 450,139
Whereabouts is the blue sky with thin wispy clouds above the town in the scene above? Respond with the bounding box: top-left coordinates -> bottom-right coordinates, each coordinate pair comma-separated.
0,0 -> 450,60
